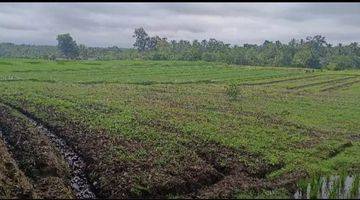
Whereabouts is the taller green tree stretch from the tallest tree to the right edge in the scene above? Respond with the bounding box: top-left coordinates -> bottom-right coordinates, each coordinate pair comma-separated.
133,28 -> 360,70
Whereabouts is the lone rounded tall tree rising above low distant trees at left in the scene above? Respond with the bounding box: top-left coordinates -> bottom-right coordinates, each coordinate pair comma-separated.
56,33 -> 79,59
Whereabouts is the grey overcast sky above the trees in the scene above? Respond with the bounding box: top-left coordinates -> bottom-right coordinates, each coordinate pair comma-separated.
0,3 -> 360,47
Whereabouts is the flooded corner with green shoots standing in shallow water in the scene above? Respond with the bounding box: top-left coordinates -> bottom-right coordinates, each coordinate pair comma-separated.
294,175 -> 360,199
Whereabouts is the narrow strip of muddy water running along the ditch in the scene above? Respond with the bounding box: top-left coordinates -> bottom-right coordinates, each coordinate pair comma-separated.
28,118 -> 96,199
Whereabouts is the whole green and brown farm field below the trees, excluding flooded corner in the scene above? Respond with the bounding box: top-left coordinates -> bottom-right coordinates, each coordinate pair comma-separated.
0,59 -> 360,198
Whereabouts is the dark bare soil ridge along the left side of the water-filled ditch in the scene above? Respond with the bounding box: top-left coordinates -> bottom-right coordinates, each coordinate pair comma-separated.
0,104 -> 74,198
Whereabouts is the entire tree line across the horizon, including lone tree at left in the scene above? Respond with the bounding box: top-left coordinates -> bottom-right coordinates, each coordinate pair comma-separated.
0,28 -> 360,70
